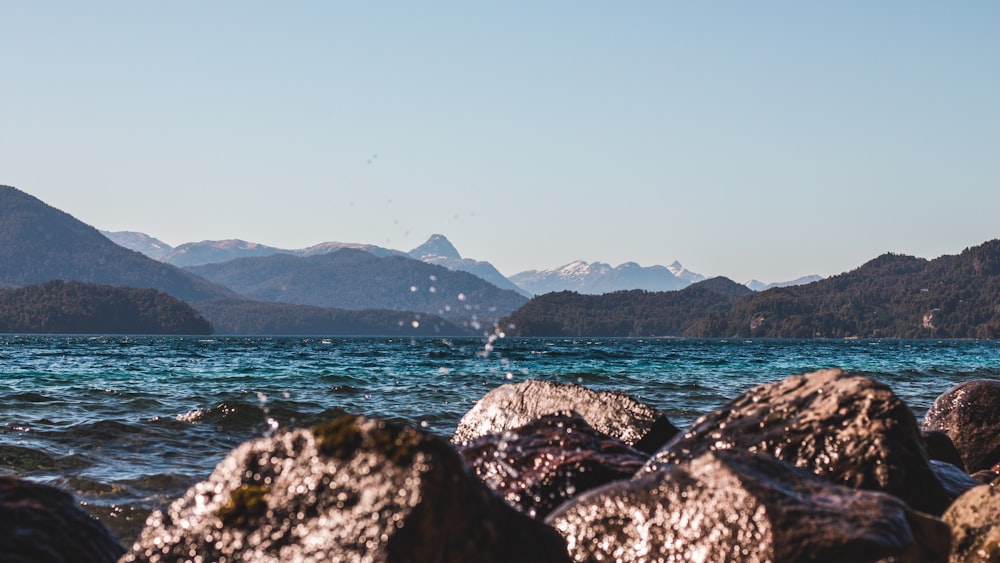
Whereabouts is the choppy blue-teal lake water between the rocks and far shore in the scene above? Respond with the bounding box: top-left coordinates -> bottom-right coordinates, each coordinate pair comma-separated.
0,336 -> 1000,540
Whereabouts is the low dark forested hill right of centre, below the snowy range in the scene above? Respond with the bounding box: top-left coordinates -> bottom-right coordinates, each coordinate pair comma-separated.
502,278 -> 753,337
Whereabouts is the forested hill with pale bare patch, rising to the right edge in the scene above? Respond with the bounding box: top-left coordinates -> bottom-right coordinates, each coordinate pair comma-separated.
701,240 -> 1000,339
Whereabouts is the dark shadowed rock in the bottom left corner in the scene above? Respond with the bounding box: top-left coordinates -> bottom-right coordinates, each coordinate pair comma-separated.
0,477 -> 125,563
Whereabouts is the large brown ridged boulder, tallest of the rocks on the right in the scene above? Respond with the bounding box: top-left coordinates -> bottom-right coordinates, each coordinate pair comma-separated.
644,369 -> 951,515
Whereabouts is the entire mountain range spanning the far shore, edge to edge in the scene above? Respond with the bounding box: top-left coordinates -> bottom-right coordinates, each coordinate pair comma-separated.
0,186 -> 1000,339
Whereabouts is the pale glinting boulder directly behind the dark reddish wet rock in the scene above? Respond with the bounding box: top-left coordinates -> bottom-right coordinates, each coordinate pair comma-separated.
452,380 -> 679,453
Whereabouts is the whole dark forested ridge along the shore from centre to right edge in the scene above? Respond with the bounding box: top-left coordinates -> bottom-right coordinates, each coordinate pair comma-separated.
505,240 -> 1000,339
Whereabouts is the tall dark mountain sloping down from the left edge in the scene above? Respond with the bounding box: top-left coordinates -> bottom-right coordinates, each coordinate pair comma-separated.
0,186 -> 235,301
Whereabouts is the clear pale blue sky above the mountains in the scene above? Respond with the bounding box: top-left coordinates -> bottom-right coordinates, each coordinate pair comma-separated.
0,0 -> 1000,281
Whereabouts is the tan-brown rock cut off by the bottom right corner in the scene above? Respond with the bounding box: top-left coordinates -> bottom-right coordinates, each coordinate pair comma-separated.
942,485 -> 1000,563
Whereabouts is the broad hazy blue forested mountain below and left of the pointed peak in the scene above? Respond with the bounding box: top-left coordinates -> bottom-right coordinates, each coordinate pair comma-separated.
189,248 -> 527,323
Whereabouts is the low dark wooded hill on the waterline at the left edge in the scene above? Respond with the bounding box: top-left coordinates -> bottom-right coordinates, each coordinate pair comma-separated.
0,281 -> 212,334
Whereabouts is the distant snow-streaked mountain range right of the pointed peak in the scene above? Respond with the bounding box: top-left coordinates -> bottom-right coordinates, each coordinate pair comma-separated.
510,260 -> 705,295
